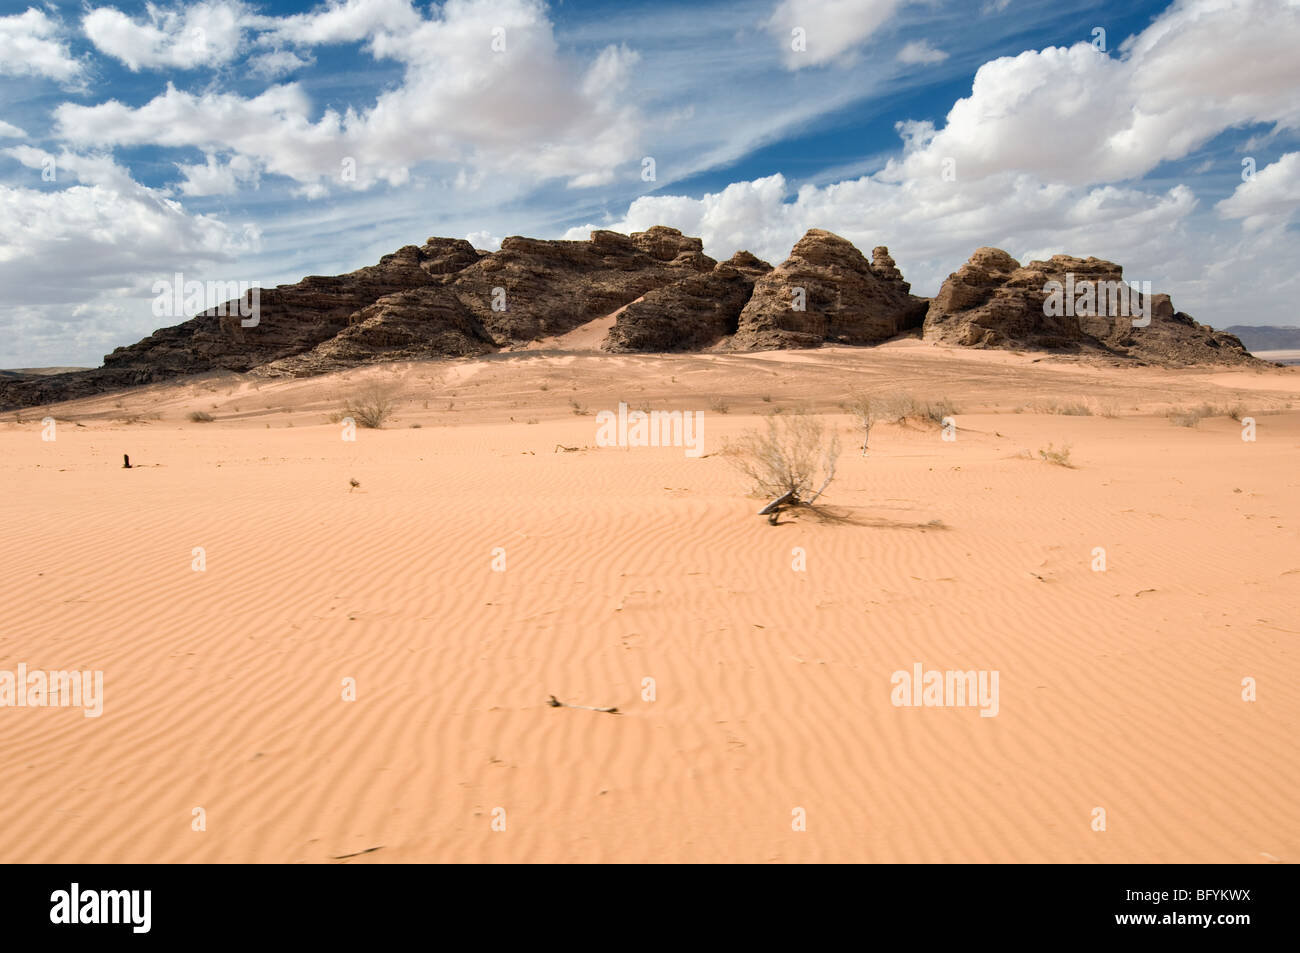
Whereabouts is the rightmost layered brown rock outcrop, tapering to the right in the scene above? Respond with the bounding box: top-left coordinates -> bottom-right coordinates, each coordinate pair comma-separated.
923,248 -> 1252,364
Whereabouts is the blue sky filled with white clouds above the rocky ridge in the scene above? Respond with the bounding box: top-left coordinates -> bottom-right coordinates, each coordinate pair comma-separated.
0,0 -> 1300,367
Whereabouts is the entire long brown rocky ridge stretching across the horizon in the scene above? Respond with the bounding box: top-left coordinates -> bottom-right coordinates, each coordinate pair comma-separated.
0,225 -> 1253,408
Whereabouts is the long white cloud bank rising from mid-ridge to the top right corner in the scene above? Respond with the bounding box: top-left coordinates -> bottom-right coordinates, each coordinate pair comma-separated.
568,0 -> 1300,324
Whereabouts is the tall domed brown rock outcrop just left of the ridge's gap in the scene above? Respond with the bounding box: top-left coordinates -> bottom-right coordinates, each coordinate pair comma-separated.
731,229 -> 927,350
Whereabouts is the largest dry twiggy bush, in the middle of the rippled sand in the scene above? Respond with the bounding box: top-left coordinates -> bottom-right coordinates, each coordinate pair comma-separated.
727,411 -> 840,517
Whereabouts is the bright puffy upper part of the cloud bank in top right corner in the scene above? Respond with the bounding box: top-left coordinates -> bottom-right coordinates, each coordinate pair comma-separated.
891,0 -> 1300,185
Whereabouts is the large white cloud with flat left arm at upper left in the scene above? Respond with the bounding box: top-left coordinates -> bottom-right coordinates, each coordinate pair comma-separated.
56,0 -> 641,196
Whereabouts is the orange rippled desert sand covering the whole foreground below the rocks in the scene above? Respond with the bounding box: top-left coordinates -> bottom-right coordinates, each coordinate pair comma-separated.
0,343 -> 1300,862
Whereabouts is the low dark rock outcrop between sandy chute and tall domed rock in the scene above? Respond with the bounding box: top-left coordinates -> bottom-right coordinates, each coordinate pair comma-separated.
601,251 -> 772,351
